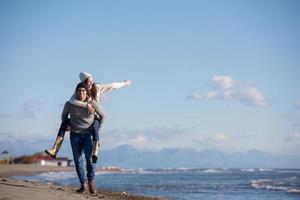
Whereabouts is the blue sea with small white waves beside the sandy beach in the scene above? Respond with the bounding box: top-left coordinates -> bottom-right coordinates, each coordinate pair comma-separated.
15,168 -> 300,200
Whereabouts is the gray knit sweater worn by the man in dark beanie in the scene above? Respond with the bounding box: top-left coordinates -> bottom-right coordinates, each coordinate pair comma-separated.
61,100 -> 105,134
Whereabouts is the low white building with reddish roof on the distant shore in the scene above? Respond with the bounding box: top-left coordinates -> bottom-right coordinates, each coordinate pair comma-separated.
33,155 -> 71,167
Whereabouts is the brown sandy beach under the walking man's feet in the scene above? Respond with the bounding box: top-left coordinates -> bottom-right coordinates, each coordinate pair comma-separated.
0,165 -> 162,200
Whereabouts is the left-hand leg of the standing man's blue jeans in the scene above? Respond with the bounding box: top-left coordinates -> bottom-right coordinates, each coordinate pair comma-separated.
70,133 -> 86,183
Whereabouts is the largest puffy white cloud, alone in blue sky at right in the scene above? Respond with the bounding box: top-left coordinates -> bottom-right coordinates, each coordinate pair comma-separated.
187,75 -> 269,107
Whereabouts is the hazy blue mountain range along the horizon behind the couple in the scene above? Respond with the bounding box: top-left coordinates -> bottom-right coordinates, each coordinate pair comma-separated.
0,141 -> 300,168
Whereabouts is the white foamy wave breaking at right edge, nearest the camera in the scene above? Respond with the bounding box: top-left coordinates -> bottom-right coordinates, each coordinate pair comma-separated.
251,177 -> 300,194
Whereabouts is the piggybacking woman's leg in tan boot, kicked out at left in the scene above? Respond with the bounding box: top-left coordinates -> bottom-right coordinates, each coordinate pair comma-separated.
45,119 -> 70,158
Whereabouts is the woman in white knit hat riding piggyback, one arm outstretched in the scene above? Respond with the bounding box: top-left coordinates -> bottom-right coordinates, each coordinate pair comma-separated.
45,72 -> 131,163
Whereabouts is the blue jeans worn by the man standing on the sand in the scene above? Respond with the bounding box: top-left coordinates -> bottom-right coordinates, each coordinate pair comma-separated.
70,132 -> 95,183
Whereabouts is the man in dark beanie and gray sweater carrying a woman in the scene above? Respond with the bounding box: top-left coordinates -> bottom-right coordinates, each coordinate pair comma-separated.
62,83 -> 104,194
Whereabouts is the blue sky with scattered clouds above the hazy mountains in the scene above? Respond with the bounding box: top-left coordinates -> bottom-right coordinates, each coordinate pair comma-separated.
0,0 -> 300,155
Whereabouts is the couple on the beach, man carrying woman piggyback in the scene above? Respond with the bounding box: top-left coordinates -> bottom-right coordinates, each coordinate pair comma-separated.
45,72 -> 131,194
